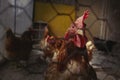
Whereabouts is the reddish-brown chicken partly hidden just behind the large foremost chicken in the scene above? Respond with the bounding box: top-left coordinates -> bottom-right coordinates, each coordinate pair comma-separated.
40,35 -> 66,62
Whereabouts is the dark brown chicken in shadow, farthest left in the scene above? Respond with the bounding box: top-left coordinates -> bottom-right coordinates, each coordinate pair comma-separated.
5,28 -> 33,61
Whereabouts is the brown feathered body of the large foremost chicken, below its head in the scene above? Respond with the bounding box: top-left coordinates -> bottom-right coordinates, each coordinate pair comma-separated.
45,36 -> 97,80
